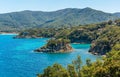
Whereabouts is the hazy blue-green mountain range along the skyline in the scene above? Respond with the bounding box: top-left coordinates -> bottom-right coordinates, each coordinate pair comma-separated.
0,8 -> 119,30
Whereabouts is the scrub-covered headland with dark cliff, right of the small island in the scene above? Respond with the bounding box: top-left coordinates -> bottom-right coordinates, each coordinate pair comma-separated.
89,26 -> 120,55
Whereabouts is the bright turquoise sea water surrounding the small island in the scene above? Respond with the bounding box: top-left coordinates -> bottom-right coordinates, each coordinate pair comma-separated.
0,35 -> 99,77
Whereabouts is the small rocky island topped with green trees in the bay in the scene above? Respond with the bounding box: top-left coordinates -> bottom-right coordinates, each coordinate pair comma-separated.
35,39 -> 73,53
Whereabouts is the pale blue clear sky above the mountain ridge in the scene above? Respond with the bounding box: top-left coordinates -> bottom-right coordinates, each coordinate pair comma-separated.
0,0 -> 120,13
